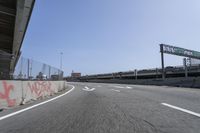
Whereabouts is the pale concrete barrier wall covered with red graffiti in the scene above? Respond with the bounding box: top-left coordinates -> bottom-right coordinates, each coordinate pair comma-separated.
0,80 -> 67,109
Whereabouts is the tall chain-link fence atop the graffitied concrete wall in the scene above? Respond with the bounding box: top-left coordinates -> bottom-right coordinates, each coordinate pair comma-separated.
13,57 -> 63,80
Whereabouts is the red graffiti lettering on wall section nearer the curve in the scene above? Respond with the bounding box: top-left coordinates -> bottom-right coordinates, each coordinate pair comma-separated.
28,81 -> 54,97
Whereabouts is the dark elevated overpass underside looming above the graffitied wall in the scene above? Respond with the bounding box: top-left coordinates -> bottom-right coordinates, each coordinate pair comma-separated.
0,0 -> 35,79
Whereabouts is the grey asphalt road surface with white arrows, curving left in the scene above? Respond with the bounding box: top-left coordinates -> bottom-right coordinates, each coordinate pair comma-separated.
0,83 -> 200,133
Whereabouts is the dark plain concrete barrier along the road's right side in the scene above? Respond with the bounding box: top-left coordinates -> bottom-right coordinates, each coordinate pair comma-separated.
89,77 -> 200,88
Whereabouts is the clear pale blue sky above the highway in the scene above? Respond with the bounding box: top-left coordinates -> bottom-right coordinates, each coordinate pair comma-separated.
22,0 -> 200,75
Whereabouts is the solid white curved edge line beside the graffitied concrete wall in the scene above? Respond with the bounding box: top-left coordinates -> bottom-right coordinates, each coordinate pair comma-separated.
0,85 -> 75,121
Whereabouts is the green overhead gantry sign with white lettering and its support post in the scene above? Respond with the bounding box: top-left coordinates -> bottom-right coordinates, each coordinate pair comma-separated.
160,44 -> 200,79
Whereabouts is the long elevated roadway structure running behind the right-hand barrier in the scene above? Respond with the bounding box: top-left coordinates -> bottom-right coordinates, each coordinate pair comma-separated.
78,64 -> 200,81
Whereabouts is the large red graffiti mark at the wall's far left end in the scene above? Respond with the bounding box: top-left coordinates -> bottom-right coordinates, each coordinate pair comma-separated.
0,81 -> 16,107
